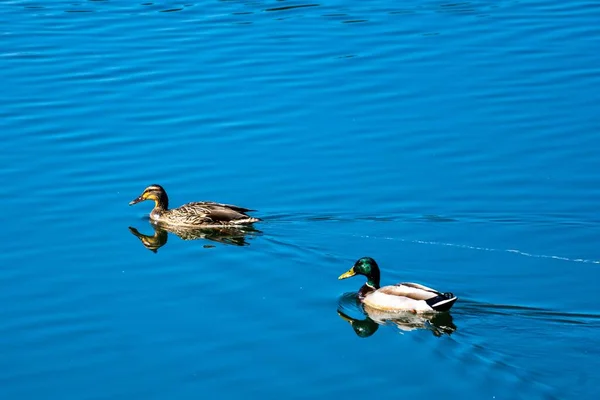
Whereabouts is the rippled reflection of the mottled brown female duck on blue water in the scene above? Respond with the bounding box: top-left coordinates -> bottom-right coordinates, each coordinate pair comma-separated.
129,223 -> 262,253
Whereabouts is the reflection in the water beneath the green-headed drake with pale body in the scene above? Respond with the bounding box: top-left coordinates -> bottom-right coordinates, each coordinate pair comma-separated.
338,310 -> 456,337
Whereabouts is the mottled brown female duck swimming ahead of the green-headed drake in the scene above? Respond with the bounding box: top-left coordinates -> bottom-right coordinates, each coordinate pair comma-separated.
129,185 -> 260,228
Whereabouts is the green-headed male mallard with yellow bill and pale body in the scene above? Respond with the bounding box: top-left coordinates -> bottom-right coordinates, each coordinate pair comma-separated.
338,257 -> 457,313
